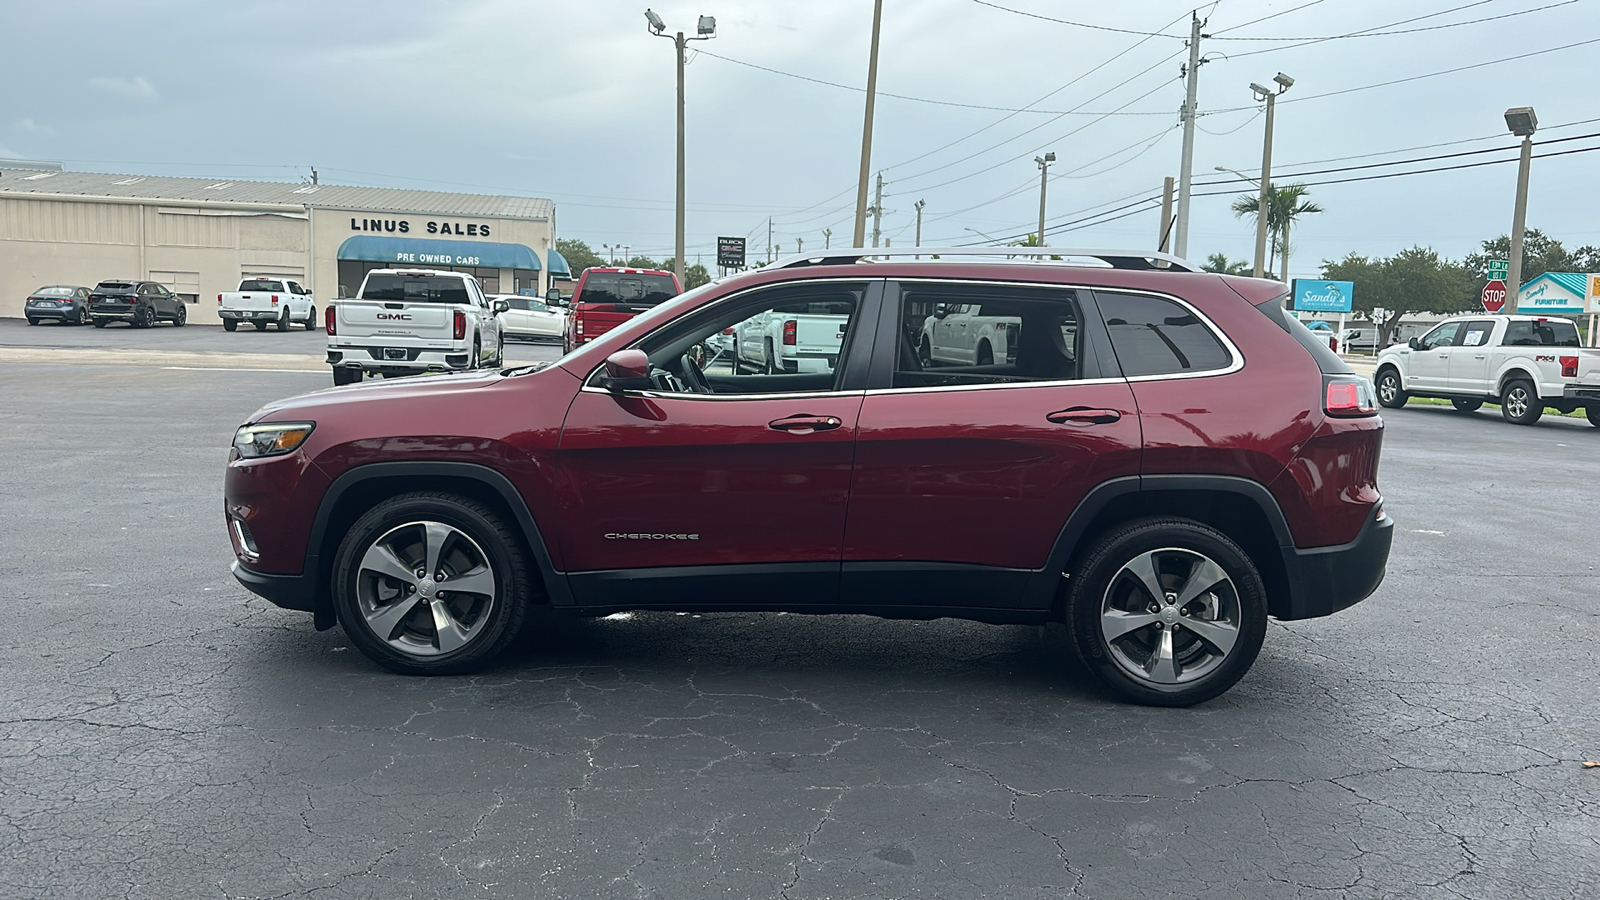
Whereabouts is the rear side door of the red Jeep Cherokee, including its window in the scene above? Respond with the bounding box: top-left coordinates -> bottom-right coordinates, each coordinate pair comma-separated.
842,282 -> 1141,609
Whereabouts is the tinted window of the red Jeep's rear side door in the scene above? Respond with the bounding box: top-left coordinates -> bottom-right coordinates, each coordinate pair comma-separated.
894,285 -> 1082,388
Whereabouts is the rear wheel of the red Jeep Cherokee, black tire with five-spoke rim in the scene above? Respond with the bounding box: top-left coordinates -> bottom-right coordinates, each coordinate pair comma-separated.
1066,517 -> 1267,706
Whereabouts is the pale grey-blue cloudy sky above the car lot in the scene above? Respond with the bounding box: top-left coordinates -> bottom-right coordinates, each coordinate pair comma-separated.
0,0 -> 1600,275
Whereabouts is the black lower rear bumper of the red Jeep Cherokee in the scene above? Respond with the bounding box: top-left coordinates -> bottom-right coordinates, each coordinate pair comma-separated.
1274,509 -> 1395,620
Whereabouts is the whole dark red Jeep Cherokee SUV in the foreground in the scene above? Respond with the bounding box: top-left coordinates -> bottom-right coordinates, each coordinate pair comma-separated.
224,248 -> 1392,706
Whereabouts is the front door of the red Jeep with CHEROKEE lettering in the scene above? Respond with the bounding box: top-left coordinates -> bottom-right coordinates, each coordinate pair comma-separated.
558,282 -> 869,609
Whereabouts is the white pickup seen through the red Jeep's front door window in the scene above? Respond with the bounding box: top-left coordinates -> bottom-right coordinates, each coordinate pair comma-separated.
731,301 -> 853,375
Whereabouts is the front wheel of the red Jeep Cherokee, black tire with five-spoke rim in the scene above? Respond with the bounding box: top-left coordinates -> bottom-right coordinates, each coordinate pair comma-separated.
333,492 -> 539,674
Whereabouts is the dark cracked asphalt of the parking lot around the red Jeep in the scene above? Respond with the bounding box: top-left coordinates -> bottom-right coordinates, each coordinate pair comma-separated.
0,328 -> 1600,900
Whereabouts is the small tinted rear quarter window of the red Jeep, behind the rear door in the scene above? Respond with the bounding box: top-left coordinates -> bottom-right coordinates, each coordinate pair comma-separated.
1094,291 -> 1232,378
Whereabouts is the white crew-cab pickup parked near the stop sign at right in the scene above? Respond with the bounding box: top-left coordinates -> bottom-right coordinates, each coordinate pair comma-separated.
1373,315 -> 1600,428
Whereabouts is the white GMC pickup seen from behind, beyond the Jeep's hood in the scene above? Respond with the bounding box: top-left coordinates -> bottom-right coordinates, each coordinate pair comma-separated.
328,269 -> 507,384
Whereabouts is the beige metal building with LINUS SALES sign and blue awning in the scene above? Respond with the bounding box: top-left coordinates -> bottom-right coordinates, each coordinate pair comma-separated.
0,160 -> 568,325
